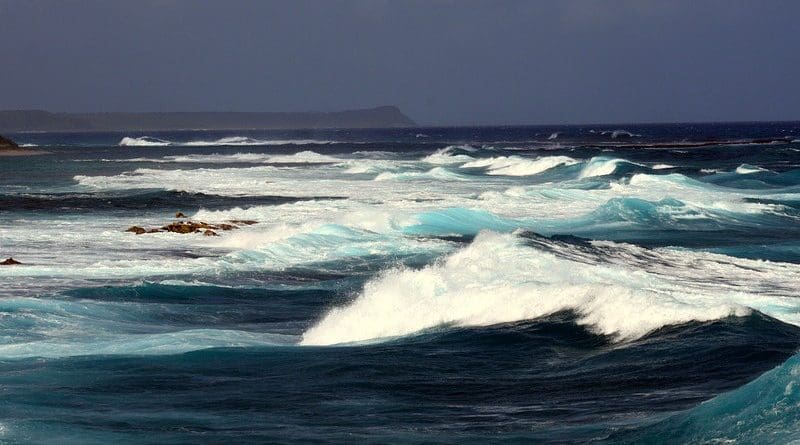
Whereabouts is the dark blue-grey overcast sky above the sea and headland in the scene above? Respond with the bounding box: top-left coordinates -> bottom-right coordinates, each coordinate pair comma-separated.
0,0 -> 800,125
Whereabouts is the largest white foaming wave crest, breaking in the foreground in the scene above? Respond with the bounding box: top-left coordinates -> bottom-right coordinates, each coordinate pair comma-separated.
301,232 -> 750,345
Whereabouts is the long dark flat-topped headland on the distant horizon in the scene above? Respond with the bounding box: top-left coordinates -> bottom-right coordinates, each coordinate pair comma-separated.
0,106 -> 416,132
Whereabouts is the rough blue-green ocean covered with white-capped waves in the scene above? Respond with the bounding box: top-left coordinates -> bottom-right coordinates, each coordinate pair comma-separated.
0,122 -> 800,444
